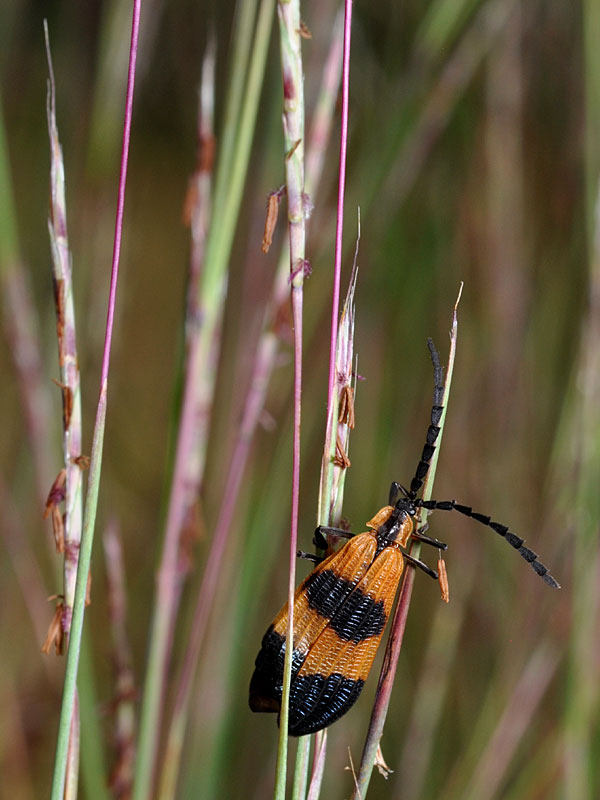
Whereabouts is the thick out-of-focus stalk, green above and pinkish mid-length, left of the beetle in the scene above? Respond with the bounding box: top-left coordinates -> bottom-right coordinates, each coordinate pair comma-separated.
133,0 -> 273,800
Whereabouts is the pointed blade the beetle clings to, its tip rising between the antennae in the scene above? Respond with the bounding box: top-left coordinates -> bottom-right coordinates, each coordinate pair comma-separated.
352,285 -> 462,800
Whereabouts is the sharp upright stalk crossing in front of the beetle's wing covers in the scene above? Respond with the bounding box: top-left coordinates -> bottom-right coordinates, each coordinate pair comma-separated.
275,0 -> 307,800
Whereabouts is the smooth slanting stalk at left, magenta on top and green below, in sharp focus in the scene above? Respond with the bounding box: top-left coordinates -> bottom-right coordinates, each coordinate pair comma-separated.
51,0 -> 141,800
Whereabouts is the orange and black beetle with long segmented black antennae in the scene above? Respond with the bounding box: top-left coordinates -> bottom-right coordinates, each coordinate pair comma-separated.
249,339 -> 560,736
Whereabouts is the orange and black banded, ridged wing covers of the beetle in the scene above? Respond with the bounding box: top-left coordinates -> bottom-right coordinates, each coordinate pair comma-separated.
250,532 -> 404,736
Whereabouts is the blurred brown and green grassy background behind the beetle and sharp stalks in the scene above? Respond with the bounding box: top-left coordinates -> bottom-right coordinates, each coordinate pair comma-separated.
0,0 -> 600,800
